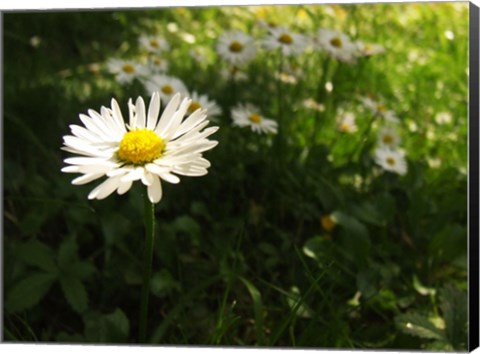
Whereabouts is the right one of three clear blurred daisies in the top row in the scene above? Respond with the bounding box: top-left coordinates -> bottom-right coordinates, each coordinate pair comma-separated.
313,28 -> 357,63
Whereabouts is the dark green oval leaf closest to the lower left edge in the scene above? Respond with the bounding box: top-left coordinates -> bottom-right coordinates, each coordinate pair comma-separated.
5,272 -> 56,312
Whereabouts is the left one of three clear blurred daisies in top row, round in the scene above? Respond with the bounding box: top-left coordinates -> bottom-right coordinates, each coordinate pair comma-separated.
217,31 -> 257,66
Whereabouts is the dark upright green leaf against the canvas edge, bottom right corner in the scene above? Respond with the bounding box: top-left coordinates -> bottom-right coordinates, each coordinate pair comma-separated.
440,284 -> 468,351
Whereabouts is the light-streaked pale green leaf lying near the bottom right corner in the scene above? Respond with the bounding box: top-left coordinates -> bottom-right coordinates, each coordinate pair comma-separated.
395,313 -> 446,341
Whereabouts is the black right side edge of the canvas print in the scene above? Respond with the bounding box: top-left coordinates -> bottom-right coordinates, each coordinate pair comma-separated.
468,2 -> 479,351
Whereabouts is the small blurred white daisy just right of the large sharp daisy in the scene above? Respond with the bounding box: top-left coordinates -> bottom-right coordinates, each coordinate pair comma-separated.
232,103 -> 278,134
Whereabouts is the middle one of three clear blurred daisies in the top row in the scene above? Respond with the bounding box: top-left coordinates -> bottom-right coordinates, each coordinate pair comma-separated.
263,26 -> 307,56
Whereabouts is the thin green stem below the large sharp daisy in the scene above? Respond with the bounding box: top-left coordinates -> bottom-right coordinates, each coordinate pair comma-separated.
139,191 -> 155,343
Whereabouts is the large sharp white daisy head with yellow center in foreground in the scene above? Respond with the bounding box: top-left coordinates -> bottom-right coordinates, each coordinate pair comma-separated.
62,92 -> 218,203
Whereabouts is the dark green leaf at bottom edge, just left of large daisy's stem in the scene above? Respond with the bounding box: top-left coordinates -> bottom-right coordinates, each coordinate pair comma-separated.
84,308 -> 130,343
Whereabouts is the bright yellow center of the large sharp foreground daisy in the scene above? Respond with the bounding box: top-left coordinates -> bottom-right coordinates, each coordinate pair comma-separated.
117,129 -> 165,165
